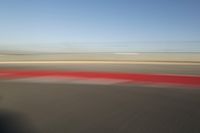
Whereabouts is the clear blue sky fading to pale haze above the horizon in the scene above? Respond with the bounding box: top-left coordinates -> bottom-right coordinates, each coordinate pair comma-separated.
0,0 -> 200,52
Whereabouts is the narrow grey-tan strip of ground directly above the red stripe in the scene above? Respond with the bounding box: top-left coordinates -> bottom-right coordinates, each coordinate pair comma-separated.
0,63 -> 200,75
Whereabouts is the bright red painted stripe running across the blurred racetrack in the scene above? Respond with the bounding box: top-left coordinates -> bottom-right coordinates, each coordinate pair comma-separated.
0,70 -> 200,87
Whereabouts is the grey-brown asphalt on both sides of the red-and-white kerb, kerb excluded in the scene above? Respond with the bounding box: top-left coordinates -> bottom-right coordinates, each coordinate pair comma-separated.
0,64 -> 200,133
